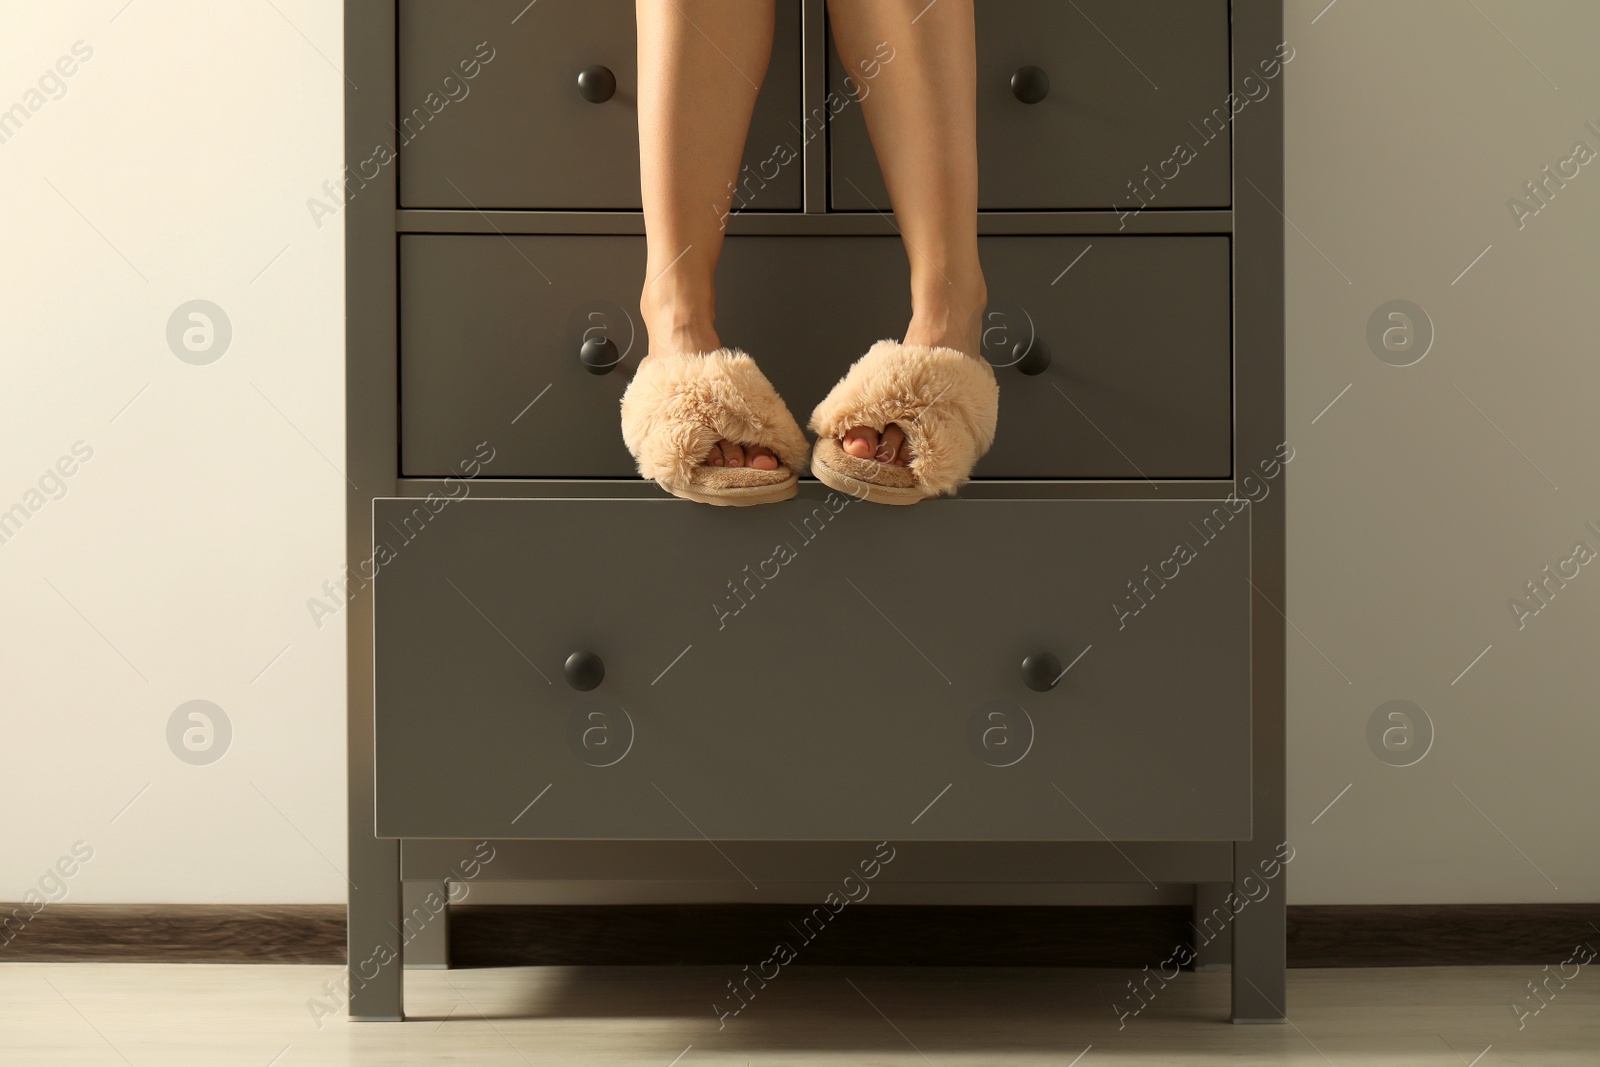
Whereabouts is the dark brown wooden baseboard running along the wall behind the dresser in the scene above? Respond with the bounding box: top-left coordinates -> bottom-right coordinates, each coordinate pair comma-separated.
0,904 -> 1600,968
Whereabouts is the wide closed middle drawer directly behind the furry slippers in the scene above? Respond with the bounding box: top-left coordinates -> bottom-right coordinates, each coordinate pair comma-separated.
400,234 -> 1234,478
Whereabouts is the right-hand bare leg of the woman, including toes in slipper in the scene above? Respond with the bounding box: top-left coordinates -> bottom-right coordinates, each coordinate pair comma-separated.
827,0 -> 989,464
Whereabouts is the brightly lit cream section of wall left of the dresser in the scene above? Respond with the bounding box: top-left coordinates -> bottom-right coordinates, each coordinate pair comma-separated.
0,0 -> 346,902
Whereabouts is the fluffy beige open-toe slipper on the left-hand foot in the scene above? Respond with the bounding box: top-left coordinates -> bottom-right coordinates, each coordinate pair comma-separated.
622,349 -> 810,506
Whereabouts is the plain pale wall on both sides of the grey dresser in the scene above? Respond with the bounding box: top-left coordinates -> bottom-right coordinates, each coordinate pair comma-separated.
0,0 -> 1600,904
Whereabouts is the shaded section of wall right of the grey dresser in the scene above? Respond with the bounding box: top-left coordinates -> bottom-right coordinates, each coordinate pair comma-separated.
1285,0 -> 1600,904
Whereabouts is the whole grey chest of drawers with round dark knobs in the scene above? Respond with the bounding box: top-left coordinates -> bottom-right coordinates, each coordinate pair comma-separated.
341,0 -> 1293,1021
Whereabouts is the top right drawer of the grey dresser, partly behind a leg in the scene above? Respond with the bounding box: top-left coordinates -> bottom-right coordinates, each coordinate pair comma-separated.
829,0 -> 1230,211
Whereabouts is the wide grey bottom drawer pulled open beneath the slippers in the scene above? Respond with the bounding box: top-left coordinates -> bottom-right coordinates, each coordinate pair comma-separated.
373,495 -> 1251,841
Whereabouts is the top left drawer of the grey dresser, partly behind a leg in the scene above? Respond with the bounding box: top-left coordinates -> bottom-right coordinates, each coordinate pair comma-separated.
395,0 -> 806,211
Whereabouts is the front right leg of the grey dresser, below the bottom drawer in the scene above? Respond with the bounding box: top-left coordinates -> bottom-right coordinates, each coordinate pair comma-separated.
1229,840 -> 1288,1022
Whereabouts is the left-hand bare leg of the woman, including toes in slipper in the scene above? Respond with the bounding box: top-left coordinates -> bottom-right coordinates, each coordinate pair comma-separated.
635,0 -> 778,470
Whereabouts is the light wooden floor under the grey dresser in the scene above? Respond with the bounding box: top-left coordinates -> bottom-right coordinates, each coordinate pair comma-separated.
0,963 -> 1600,1067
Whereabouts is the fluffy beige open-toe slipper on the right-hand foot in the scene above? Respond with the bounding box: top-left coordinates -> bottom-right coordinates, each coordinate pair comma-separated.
811,341 -> 1000,504
